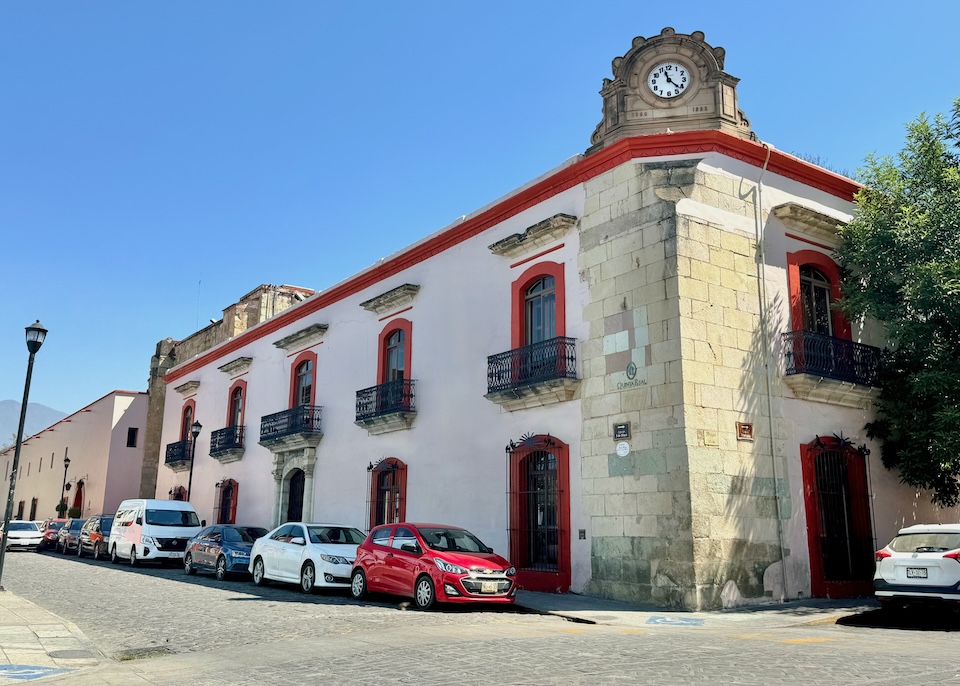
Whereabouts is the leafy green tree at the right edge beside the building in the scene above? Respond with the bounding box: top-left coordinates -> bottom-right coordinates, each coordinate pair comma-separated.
836,98 -> 960,506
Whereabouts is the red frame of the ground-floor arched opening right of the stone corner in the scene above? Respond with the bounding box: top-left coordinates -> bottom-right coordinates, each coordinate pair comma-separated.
800,437 -> 873,598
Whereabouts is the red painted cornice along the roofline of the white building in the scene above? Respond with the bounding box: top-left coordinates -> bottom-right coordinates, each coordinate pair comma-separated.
164,131 -> 860,383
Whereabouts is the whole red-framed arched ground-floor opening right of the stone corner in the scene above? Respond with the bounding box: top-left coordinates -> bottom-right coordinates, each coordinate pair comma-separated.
800,436 -> 876,598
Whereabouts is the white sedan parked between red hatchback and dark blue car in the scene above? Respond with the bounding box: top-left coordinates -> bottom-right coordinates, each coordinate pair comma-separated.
250,522 -> 364,593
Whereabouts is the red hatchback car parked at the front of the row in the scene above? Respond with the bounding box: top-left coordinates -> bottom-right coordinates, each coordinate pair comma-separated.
350,522 -> 517,610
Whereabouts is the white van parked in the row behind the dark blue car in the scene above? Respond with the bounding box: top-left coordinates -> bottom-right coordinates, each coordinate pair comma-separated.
107,499 -> 201,565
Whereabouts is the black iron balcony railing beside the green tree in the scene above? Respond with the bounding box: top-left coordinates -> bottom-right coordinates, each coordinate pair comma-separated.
782,331 -> 880,386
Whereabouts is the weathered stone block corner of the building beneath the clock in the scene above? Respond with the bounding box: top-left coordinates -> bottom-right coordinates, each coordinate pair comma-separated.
580,160 -> 790,609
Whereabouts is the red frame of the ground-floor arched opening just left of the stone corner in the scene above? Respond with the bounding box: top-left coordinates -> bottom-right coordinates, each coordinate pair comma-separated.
507,435 -> 570,593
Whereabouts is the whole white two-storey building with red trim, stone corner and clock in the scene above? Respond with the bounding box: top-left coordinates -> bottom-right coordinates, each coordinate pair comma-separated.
157,29 -> 958,609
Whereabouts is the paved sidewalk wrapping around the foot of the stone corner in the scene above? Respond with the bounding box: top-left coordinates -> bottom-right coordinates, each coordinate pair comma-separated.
517,591 -> 880,628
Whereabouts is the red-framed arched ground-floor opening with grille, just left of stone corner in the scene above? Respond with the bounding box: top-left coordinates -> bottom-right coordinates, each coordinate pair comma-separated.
507,435 -> 570,593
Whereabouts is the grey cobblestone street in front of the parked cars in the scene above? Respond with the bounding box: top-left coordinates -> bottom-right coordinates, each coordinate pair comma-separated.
0,553 -> 960,686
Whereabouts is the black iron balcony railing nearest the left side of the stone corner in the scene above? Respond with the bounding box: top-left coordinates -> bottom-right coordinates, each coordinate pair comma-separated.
487,336 -> 577,393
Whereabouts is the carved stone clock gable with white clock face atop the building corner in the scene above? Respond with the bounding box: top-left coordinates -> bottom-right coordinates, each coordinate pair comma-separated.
587,27 -> 756,154
